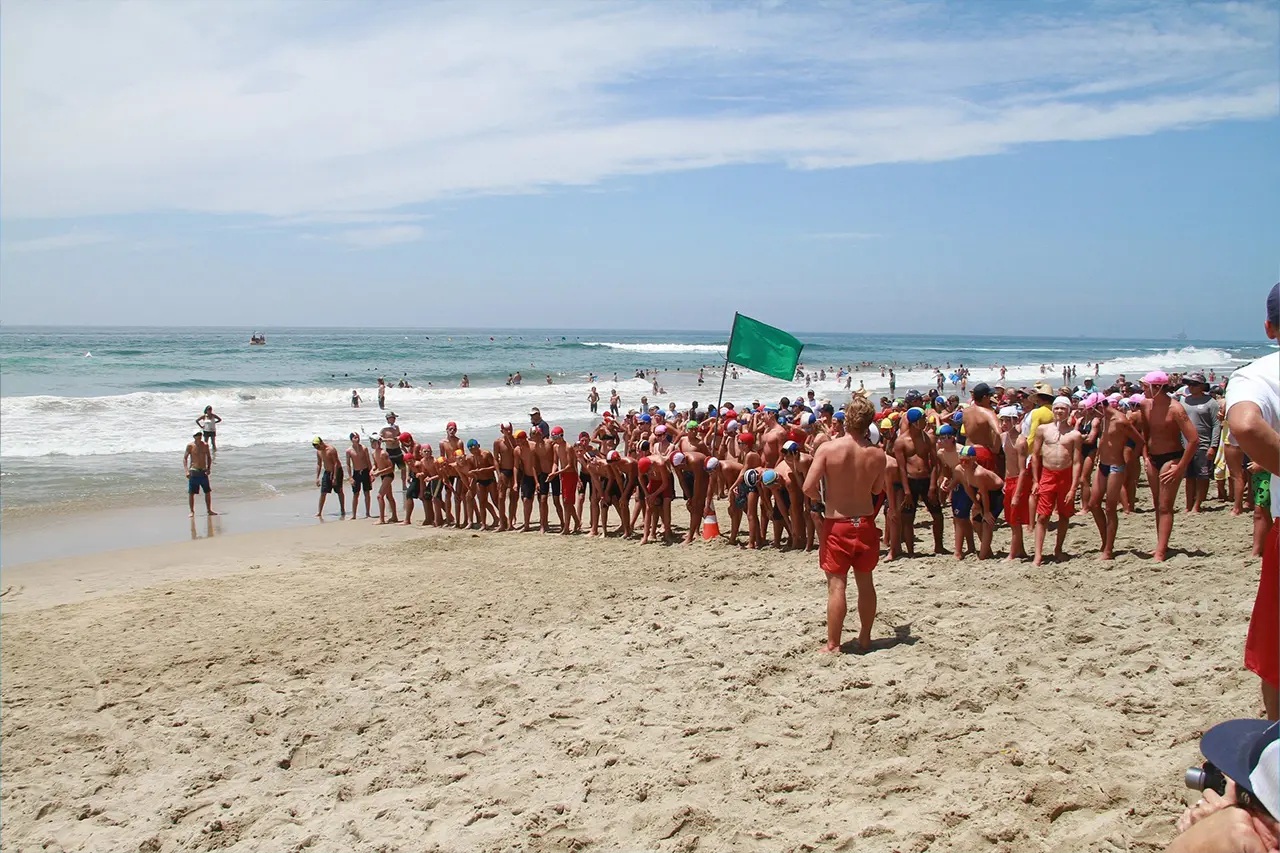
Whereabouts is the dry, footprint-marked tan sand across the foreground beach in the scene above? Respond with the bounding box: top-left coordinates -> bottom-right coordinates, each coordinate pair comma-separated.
0,503 -> 1261,850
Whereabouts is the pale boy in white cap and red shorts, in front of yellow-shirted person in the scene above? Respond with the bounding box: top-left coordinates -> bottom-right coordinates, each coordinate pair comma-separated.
1032,397 -> 1084,566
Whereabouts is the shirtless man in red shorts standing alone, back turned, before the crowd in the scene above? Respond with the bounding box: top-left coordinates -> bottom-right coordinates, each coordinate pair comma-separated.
804,397 -> 886,653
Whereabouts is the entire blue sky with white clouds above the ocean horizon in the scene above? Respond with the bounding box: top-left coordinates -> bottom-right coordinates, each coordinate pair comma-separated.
0,0 -> 1280,338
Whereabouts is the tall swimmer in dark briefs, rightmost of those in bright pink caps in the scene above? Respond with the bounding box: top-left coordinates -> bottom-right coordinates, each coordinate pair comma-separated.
1142,370 -> 1199,562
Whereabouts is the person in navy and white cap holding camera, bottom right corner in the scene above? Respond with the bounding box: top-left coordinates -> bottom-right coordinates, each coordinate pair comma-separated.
1166,720 -> 1280,853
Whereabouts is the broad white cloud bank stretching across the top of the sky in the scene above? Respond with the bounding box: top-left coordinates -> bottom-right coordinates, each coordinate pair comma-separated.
0,0 -> 1280,219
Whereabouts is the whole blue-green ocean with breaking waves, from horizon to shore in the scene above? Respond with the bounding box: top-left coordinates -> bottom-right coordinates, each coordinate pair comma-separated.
0,327 -> 1267,516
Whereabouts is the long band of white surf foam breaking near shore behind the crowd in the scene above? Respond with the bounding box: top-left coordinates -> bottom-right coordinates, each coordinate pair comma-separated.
0,345 -> 1240,459
